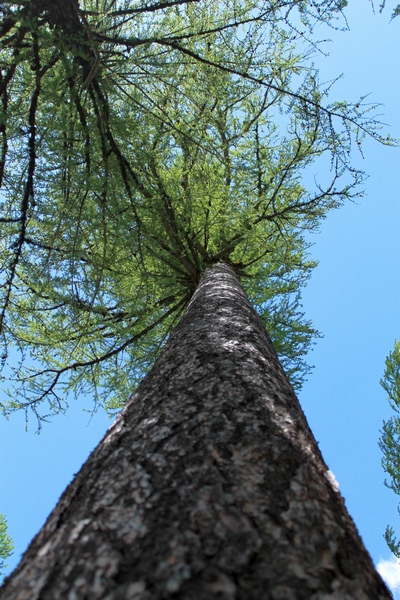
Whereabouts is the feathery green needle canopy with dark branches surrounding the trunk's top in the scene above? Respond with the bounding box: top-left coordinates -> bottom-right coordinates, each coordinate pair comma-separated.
0,0 -> 394,423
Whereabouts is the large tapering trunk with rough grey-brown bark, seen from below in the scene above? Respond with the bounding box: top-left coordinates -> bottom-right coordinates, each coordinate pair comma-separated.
0,265 -> 391,600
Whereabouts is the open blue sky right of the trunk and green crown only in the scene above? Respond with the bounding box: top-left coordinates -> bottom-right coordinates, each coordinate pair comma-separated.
300,1 -> 400,598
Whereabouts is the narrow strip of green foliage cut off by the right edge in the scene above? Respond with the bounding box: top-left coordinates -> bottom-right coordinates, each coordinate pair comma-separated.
379,340 -> 400,558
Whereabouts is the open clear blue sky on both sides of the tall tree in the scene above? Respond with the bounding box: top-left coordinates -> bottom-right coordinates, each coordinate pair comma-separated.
0,0 -> 400,597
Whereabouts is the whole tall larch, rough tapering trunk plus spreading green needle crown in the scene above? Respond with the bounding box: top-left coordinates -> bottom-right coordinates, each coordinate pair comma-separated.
0,0 -> 390,599
